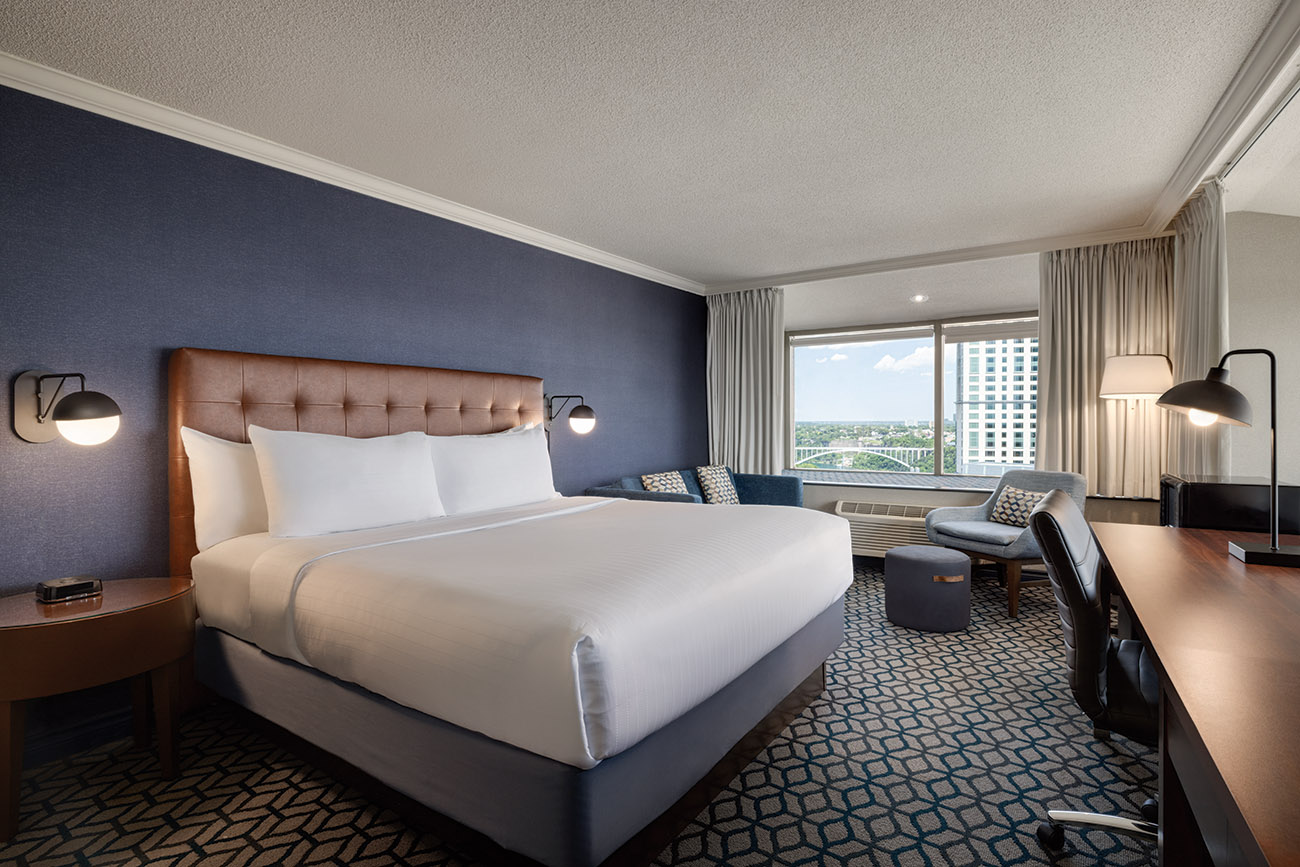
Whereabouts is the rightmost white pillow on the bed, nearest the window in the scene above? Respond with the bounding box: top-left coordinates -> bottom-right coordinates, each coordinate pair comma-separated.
429,426 -> 559,515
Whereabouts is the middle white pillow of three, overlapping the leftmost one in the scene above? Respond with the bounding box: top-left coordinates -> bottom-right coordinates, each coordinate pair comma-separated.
248,425 -> 446,536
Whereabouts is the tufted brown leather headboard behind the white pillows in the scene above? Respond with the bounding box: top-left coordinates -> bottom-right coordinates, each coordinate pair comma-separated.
168,348 -> 545,576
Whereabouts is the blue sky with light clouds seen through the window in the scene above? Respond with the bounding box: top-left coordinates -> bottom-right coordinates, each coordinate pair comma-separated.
794,337 -> 957,421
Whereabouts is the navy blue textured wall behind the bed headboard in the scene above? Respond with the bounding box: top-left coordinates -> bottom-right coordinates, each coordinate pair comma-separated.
0,88 -> 709,593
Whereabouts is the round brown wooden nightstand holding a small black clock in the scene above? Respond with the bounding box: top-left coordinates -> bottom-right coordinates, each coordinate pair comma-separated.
0,578 -> 194,842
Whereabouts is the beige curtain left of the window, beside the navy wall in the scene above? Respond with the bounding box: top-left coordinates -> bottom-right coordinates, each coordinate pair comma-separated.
707,289 -> 785,473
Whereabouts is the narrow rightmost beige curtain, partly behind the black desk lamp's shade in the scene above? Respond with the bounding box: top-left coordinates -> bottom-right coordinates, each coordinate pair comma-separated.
1169,181 -> 1227,476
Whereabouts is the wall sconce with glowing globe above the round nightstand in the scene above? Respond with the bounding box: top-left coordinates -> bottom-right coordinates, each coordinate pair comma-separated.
13,370 -> 122,446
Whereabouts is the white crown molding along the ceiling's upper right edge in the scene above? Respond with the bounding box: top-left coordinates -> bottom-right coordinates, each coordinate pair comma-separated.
1145,0 -> 1300,231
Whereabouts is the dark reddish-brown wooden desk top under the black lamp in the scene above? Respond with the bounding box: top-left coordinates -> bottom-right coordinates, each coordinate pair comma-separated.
1092,523 -> 1300,864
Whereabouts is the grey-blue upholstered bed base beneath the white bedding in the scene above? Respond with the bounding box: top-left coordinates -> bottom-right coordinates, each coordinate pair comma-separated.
195,598 -> 844,867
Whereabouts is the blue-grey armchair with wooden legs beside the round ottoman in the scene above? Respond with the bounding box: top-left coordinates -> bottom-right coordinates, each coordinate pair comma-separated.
926,469 -> 1088,617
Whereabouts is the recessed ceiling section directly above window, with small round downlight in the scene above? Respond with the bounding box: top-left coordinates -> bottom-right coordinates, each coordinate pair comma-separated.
785,253 -> 1039,331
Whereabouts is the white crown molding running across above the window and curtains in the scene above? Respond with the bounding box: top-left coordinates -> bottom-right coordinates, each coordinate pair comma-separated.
705,226 -> 1173,295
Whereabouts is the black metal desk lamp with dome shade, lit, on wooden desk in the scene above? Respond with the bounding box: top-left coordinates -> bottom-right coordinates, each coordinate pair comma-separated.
1156,350 -> 1300,567
